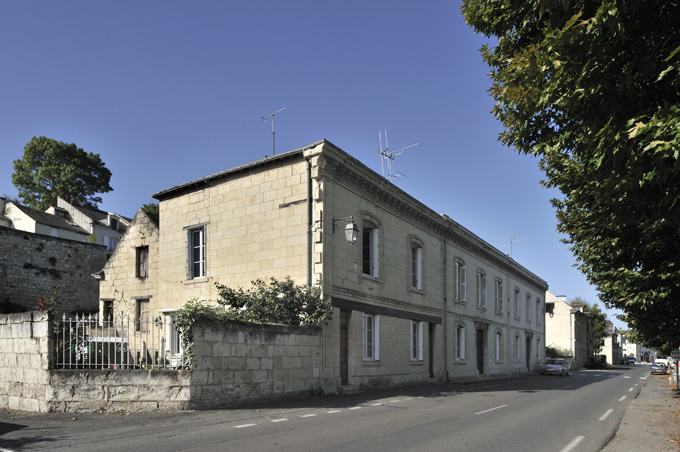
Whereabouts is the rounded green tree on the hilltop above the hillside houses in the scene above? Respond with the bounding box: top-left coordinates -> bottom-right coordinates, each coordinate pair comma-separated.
12,137 -> 113,210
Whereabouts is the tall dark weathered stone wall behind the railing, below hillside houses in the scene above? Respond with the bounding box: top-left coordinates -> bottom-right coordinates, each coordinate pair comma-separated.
0,227 -> 107,315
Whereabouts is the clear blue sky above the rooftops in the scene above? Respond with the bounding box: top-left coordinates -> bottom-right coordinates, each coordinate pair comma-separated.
0,0 -> 624,327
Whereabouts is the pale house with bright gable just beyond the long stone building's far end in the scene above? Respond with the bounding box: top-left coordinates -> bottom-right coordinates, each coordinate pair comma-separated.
545,292 -> 593,369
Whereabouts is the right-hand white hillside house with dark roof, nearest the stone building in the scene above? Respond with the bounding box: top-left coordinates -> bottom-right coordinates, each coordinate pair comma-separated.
47,197 -> 131,251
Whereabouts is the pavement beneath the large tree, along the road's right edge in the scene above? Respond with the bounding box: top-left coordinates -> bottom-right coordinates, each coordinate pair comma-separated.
601,364 -> 680,452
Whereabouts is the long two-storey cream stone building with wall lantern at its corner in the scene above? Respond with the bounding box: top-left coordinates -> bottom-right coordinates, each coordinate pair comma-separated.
100,140 -> 547,392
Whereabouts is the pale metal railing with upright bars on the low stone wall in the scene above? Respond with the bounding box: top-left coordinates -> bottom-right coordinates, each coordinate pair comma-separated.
54,314 -> 188,370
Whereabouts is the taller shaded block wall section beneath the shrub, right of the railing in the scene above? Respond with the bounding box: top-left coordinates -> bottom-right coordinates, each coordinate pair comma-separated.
191,323 -> 321,408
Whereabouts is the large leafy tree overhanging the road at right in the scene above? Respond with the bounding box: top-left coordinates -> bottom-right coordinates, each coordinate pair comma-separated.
462,0 -> 680,347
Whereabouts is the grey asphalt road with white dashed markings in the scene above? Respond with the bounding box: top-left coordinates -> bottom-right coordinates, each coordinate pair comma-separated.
0,365 -> 649,452
